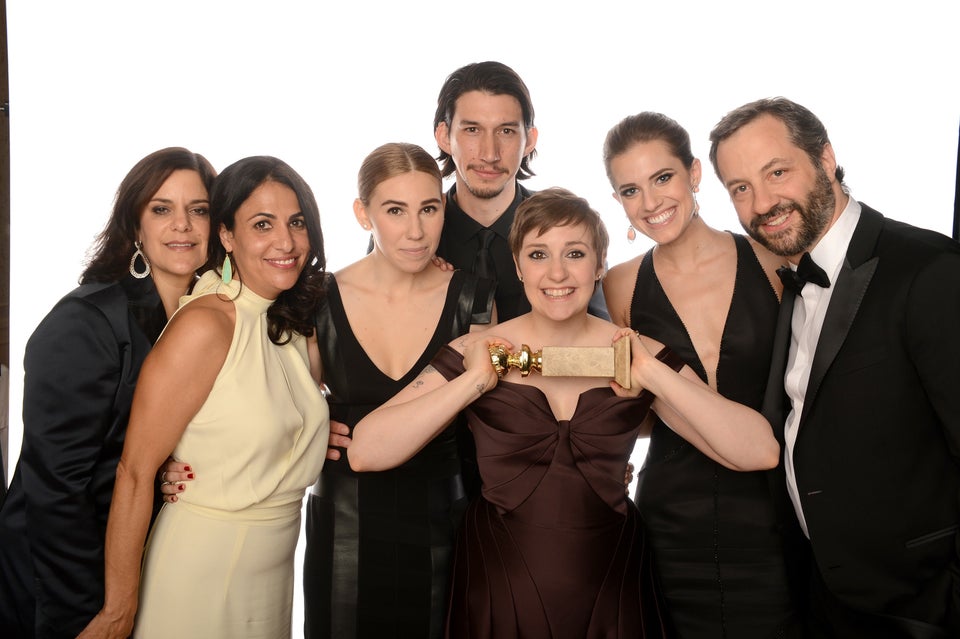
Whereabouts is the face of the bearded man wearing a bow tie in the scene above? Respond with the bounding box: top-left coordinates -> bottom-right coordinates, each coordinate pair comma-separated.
717,115 -> 842,262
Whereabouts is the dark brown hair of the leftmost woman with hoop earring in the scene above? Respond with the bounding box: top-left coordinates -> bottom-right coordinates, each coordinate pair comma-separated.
80,147 -> 217,284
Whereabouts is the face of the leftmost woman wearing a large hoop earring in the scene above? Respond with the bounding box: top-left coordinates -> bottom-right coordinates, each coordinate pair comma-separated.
137,169 -> 210,289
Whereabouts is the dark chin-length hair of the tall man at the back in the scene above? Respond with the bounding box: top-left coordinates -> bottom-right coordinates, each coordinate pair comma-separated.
433,61 -> 537,180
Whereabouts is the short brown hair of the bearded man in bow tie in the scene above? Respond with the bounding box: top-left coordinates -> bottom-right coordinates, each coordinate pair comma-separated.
710,97 -> 844,187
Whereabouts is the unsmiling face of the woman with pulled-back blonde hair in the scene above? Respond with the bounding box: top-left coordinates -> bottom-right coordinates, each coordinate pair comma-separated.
353,171 -> 444,273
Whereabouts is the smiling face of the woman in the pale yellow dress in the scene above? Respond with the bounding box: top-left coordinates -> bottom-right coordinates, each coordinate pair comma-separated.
220,181 -> 310,299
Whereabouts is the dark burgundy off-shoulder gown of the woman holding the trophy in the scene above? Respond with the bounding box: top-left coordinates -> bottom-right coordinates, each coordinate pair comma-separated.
433,347 -> 683,639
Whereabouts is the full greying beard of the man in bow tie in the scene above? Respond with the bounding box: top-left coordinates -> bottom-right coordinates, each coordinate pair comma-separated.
743,167 -> 837,257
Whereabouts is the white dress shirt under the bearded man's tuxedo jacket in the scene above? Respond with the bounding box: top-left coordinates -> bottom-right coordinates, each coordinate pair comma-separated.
783,194 -> 860,538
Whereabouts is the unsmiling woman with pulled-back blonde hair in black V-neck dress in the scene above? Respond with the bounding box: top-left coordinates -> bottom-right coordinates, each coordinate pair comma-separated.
303,144 -> 493,639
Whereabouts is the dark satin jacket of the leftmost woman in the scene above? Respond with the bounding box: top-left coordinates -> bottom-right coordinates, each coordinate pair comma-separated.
0,276 -> 166,639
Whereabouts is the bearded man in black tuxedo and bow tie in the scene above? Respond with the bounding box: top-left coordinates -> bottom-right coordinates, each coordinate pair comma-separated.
710,98 -> 960,639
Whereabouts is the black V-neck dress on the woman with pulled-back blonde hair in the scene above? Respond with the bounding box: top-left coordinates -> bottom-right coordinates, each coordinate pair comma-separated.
303,271 -> 493,639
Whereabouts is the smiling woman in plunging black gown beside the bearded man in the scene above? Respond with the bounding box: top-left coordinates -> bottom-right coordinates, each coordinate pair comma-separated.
604,112 -> 799,639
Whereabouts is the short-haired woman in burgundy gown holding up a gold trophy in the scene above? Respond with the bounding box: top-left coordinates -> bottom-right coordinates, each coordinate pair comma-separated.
347,189 -> 779,639
